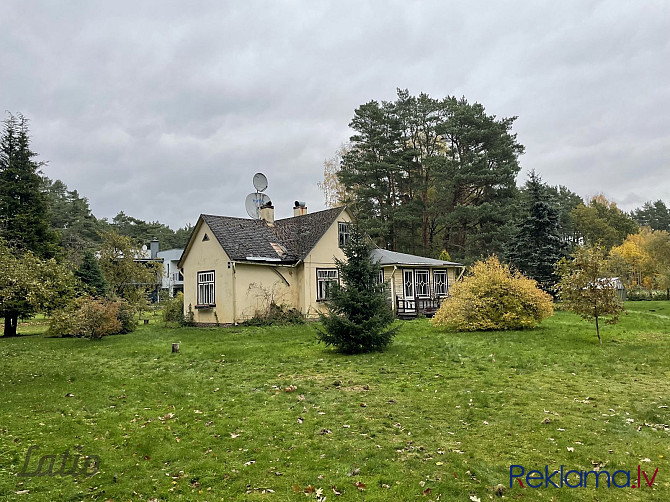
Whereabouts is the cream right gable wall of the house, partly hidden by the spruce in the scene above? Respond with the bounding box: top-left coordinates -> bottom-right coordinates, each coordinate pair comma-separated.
298,211 -> 351,317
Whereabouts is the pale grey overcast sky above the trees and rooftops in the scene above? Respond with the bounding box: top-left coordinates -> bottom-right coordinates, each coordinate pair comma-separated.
0,0 -> 670,228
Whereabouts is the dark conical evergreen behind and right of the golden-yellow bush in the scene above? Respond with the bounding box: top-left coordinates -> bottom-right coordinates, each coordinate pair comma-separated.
507,171 -> 565,291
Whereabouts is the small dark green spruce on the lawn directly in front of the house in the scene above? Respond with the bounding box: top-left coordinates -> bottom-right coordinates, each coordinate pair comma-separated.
317,225 -> 398,354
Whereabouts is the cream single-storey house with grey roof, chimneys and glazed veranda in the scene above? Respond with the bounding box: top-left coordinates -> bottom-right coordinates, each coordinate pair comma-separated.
178,202 -> 460,325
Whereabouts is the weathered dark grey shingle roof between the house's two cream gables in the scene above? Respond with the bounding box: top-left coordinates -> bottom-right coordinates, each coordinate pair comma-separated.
201,207 -> 344,264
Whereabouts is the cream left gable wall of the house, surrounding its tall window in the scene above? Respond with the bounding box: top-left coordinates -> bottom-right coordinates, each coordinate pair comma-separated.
182,221 -> 234,324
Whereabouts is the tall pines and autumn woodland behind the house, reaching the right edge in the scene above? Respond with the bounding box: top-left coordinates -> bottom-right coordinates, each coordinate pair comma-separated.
319,90 -> 670,264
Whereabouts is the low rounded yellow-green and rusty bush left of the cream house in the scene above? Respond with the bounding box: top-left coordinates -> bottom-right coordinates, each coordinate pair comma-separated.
47,296 -> 137,340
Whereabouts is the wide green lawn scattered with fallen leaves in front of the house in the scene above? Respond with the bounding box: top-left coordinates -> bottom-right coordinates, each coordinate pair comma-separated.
0,302 -> 670,502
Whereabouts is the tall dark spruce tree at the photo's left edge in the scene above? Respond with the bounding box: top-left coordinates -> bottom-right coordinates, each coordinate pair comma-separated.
0,114 -> 58,258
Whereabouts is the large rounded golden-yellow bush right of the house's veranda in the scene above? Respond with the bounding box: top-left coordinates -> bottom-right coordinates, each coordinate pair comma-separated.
431,256 -> 554,331
